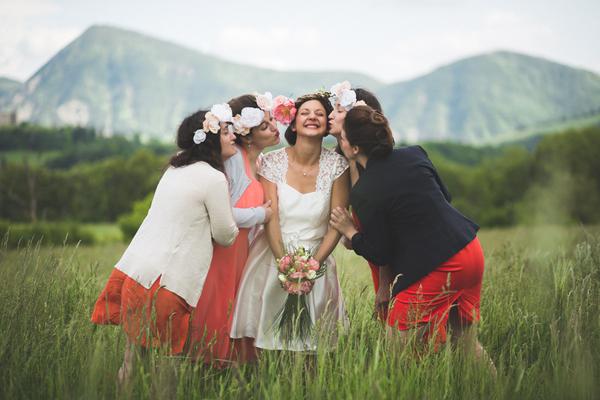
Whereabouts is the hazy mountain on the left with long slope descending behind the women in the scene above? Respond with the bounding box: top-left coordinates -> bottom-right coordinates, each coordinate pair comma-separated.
0,26 -> 381,137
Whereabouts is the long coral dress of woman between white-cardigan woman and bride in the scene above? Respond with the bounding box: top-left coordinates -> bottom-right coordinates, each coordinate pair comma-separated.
190,149 -> 264,366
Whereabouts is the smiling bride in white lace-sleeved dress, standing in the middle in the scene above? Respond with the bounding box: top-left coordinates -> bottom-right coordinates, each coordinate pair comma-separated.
231,93 -> 350,351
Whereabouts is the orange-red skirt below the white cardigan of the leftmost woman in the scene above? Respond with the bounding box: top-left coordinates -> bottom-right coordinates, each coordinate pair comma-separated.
91,268 -> 192,354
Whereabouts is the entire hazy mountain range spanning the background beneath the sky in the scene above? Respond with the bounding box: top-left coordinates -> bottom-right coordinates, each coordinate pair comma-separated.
0,26 -> 600,144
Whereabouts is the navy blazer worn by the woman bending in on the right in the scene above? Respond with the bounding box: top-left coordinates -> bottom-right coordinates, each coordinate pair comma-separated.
350,146 -> 479,296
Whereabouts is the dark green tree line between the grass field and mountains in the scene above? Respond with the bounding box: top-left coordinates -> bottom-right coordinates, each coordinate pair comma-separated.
0,126 -> 600,234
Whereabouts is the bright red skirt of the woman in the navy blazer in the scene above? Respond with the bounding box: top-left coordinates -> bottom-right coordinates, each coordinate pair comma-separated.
387,238 -> 484,343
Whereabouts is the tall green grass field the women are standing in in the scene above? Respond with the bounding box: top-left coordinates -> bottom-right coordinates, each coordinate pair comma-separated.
0,227 -> 600,399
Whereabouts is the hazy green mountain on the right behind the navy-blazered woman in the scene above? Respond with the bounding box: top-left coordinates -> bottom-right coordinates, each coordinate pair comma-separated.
379,51 -> 600,143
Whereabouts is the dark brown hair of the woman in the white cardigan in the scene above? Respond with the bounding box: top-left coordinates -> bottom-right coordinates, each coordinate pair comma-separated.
169,110 -> 224,172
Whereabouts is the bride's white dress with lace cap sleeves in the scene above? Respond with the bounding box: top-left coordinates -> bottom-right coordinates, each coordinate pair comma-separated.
231,148 -> 348,351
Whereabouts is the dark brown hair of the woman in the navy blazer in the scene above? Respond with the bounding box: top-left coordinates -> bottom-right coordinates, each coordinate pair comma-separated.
344,106 -> 394,158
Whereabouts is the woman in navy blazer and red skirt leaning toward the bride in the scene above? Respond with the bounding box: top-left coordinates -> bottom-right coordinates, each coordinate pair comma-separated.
331,106 -> 487,368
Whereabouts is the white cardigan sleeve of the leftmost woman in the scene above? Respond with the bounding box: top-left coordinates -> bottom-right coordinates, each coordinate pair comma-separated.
205,176 -> 238,246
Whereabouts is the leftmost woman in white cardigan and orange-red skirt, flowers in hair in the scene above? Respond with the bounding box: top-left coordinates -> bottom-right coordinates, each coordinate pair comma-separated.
92,104 -> 238,382
